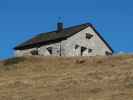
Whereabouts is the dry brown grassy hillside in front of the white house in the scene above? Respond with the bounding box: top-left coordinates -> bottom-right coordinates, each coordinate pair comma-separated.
0,55 -> 133,100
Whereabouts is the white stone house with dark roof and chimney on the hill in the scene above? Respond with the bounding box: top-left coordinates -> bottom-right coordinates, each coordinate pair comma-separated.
14,23 -> 113,57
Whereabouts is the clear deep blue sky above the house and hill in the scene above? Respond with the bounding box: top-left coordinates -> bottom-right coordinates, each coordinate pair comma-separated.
0,0 -> 133,59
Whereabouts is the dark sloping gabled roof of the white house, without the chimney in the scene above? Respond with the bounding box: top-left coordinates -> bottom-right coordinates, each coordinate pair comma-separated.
14,23 -> 113,52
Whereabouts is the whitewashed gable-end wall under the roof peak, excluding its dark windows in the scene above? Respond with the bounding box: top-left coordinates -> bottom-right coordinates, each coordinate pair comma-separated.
62,27 -> 112,56
